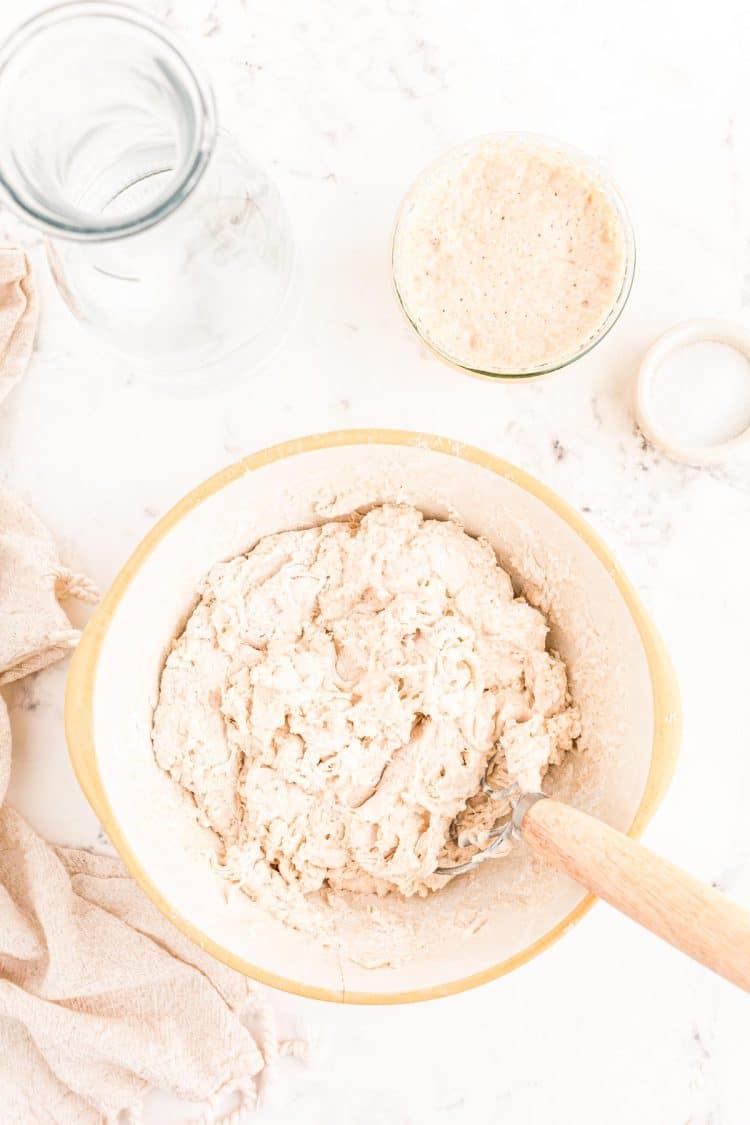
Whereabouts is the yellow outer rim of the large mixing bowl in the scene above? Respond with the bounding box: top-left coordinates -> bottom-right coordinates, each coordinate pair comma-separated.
65,429 -> 681,1004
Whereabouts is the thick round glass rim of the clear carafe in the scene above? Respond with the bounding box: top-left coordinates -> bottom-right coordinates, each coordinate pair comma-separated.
0,0 -> 217,242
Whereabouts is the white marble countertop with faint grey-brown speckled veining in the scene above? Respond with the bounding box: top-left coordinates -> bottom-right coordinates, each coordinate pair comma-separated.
0,0 -> 750,1125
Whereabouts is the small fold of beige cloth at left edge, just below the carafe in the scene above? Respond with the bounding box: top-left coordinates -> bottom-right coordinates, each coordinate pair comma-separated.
0,246 -> 38,402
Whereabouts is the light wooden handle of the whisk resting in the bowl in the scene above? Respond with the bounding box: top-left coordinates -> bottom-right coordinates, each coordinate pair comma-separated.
518,798 -> 750,992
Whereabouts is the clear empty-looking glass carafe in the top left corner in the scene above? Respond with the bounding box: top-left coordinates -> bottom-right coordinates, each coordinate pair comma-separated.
0,2 -> 292,375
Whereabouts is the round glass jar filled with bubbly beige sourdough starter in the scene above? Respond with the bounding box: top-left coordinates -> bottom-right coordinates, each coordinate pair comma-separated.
392,133 -> 635,380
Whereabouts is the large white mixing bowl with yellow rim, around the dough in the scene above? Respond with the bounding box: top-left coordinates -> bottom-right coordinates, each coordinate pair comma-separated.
65,430 -> 680,1004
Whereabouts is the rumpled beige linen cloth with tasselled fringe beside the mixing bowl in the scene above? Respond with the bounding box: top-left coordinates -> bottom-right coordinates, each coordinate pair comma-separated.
0,257 -> 306,1125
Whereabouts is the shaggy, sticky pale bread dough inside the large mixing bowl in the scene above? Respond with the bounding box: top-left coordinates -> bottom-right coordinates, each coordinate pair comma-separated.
153,505 -> 579,924
